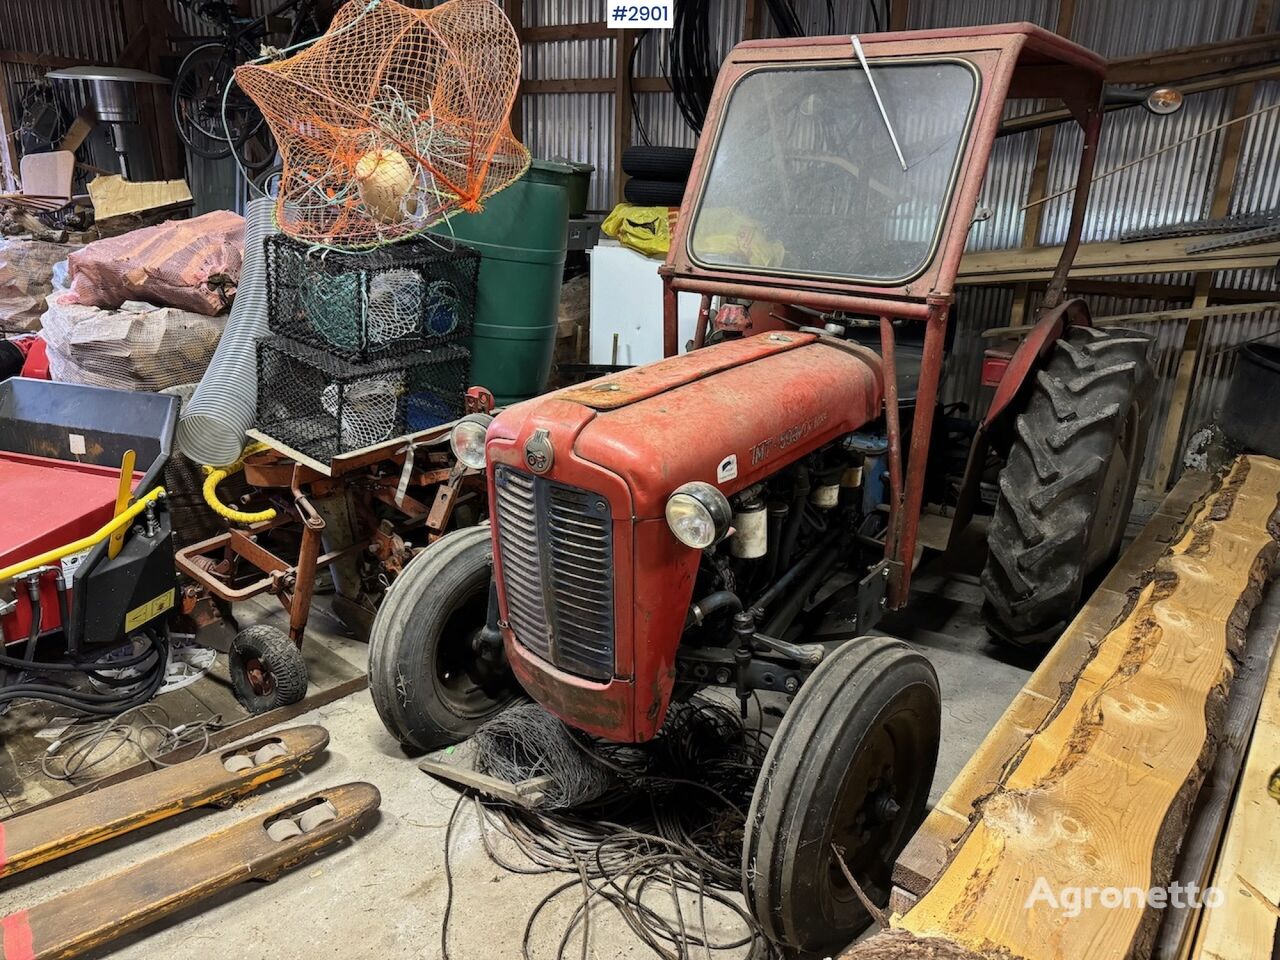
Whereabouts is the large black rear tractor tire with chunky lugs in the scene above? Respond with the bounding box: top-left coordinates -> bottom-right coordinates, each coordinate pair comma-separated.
982,326 -> 1155,646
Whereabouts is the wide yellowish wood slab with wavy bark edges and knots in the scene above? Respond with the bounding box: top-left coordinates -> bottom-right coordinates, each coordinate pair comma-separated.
847,457 -> 1280,960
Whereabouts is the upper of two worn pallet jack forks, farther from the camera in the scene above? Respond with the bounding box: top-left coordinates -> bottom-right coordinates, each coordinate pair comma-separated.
0,726 -> 329,880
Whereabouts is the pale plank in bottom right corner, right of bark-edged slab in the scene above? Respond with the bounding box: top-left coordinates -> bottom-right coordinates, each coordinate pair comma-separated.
1194,619 -> 1280,960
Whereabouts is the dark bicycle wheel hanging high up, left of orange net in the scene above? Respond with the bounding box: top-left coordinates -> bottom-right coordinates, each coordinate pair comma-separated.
173,44 -> 264,160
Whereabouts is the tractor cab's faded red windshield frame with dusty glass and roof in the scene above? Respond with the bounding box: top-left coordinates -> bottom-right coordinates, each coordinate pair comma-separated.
662,23 -> 1106,320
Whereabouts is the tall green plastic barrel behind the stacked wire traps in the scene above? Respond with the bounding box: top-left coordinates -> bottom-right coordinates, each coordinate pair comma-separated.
434,160 -> 573,404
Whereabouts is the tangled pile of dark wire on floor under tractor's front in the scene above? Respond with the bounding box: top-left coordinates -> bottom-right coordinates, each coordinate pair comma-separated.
440,698 -> 778,960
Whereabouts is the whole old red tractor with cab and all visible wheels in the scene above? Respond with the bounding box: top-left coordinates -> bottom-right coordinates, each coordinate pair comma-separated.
370,23 -> 1152,950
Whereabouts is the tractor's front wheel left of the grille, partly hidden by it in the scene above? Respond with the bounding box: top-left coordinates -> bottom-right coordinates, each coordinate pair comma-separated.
369,524 -> 524,751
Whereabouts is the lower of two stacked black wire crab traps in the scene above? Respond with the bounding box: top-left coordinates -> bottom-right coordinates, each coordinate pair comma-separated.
257,337 -> 471,463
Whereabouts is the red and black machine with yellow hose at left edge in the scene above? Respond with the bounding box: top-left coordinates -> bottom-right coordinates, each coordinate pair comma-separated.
0,376 -> 177,716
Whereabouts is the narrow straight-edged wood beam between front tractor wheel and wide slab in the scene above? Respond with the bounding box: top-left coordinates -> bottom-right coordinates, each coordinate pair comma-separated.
893,471 -> 1213,900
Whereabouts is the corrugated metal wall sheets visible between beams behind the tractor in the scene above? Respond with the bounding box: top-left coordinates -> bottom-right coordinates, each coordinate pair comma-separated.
0,0 -> 1280,475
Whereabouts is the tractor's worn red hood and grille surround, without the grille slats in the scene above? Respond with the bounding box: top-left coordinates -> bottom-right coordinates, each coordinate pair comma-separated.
486,334 -> 883,741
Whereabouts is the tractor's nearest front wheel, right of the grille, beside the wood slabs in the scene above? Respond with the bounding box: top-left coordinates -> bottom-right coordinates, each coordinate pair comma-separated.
742,636 -> 942,955
